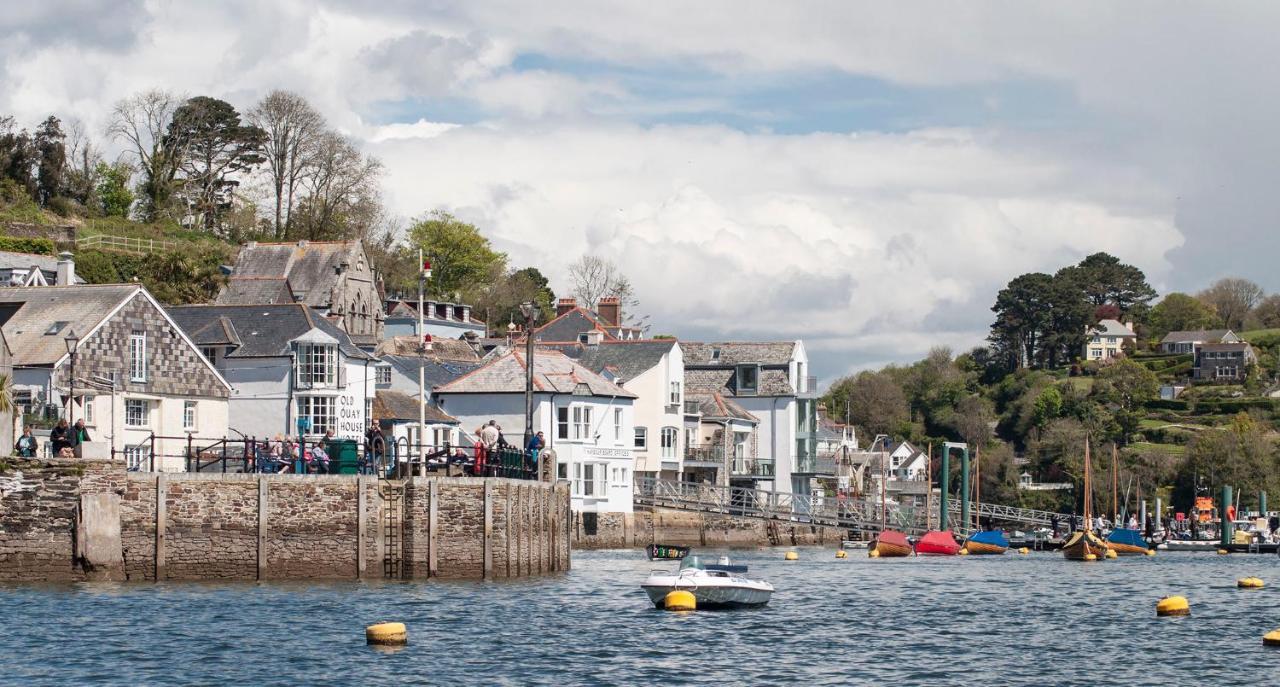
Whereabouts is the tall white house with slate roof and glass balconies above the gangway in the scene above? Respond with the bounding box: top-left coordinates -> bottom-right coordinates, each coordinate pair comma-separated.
680,340 -> 819,495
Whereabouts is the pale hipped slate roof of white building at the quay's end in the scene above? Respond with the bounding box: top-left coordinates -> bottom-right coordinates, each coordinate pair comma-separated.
435,351 -> 636,398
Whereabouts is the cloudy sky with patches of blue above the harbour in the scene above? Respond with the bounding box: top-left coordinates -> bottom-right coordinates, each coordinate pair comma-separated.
0,0 -> 1280,381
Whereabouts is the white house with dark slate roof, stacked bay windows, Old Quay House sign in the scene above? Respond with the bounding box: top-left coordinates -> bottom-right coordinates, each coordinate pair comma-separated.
169,303 -> 376,440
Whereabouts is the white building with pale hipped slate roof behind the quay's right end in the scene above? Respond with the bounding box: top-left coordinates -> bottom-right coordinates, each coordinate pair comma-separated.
433,349 -> 636,513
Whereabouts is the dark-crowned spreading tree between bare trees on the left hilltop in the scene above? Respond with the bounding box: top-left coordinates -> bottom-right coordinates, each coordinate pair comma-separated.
168,96 -> 266,232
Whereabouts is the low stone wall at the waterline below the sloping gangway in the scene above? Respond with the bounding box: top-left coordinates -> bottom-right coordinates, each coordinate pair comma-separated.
572,508 -> 845,549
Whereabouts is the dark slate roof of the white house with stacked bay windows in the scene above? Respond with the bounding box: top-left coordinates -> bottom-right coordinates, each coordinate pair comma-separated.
166,303 -> 370,359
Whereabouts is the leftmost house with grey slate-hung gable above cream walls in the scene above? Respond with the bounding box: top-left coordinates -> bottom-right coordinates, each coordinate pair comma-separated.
0,284 -> 232,471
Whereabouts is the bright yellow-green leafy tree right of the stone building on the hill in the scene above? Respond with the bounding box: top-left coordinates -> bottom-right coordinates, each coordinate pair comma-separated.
408,210 -> 507,298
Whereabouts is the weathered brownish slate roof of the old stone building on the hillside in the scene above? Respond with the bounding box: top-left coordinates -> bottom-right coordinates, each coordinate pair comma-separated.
218,241 -> 360,307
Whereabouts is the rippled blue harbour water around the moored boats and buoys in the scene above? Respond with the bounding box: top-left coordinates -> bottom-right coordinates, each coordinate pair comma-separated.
0,549 -> 1280,684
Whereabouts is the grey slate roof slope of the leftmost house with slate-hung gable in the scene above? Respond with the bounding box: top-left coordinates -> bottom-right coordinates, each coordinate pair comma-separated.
0,284 -> 142,366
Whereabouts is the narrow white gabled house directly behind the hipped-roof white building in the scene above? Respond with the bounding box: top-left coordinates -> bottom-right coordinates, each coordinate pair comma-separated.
535,340 -> 689,480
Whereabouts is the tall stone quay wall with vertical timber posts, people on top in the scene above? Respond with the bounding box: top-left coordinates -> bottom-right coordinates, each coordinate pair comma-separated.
0,459 -> 571,581
